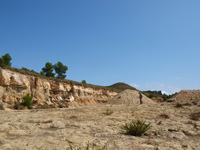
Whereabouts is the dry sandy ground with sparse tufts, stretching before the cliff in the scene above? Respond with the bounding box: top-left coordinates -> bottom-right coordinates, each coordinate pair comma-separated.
0,103 -> 200,150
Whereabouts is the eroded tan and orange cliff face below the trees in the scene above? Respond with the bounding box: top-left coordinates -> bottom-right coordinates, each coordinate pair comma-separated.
0,68 -> 117,107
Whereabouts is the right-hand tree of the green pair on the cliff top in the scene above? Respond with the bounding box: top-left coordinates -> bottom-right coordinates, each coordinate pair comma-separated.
54,62 -> 68,79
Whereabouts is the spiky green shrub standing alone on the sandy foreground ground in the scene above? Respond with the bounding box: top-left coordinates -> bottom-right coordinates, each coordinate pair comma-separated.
122,120 -> 151,136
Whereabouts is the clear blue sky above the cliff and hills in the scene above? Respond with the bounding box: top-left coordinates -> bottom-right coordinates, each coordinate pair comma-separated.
0,0 -> 200,93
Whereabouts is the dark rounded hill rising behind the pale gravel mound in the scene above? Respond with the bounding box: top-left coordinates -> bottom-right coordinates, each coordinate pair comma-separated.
108,82 -> 137,92
